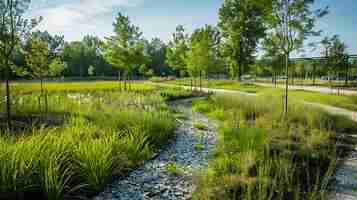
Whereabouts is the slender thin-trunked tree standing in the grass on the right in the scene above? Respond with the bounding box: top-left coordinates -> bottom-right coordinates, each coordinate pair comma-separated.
269,0 -> 327,116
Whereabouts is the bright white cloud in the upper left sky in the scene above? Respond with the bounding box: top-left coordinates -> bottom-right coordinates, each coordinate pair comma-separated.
30,0 -> 142,39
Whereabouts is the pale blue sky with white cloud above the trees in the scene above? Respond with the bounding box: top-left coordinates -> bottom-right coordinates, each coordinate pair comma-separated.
29,0 -> 357,54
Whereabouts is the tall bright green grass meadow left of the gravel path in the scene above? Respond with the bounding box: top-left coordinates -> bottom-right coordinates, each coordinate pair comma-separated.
0,82 -> 192,200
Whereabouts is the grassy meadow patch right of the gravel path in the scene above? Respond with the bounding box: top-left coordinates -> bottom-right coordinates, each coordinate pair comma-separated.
193,94 -> 357,200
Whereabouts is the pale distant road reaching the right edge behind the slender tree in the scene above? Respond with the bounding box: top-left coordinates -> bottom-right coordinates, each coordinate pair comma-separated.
255,83 -> 357,96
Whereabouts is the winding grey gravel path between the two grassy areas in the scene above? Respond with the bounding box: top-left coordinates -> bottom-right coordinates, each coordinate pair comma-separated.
94,100 -> 217,200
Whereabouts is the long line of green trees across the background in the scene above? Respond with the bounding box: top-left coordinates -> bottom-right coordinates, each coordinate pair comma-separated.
2,0 -> 346,83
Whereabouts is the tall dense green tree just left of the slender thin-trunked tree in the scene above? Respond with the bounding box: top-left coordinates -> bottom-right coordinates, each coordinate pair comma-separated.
219,0 -> 270,79
